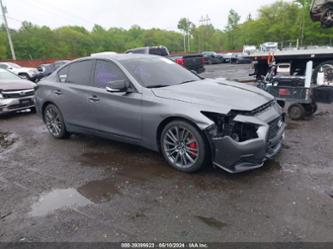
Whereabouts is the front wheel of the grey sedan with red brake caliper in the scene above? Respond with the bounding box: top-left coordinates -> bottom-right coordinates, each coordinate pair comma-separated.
160,120 -> 210,173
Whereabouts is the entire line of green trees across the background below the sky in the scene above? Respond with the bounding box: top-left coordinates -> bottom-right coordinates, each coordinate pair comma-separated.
0,0 -> 333,60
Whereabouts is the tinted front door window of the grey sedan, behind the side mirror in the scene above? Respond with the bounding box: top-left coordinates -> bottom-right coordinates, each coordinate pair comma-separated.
94,60 -> 127,88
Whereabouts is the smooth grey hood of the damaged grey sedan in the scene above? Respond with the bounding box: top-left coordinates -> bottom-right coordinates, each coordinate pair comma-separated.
152,79 -> 273,111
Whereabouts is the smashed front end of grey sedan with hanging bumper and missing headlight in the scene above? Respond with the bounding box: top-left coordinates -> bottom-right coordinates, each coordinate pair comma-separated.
203,101 -> 285,173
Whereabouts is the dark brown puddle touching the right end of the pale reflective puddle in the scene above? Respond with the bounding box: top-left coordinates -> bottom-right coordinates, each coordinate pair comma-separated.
77,179 -> 119,203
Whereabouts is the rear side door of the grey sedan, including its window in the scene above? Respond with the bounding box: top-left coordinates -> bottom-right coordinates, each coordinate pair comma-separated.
52,59 -> 99,128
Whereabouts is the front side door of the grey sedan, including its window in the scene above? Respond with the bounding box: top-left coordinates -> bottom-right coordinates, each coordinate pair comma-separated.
88,59 -> 142,143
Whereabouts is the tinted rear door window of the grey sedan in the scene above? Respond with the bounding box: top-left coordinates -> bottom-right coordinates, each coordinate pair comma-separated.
66,60 -> 94,85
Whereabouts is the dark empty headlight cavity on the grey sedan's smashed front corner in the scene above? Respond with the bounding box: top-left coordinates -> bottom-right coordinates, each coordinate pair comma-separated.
201,112 -> 258,142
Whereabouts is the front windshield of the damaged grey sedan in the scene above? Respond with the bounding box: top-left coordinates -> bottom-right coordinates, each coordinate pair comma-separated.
120,57 -> 200,88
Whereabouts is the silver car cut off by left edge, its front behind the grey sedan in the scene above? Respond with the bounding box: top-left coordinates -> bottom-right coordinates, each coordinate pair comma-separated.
0,68 -> 36,114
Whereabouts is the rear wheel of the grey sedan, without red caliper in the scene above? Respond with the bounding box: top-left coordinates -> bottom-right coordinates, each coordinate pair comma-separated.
43,104 -> 70,139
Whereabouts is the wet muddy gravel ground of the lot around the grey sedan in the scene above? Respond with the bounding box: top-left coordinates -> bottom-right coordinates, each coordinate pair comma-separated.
0,65 -> 333,242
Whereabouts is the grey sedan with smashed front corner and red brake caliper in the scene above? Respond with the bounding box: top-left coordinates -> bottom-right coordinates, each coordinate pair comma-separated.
36,54 -> 285,173
